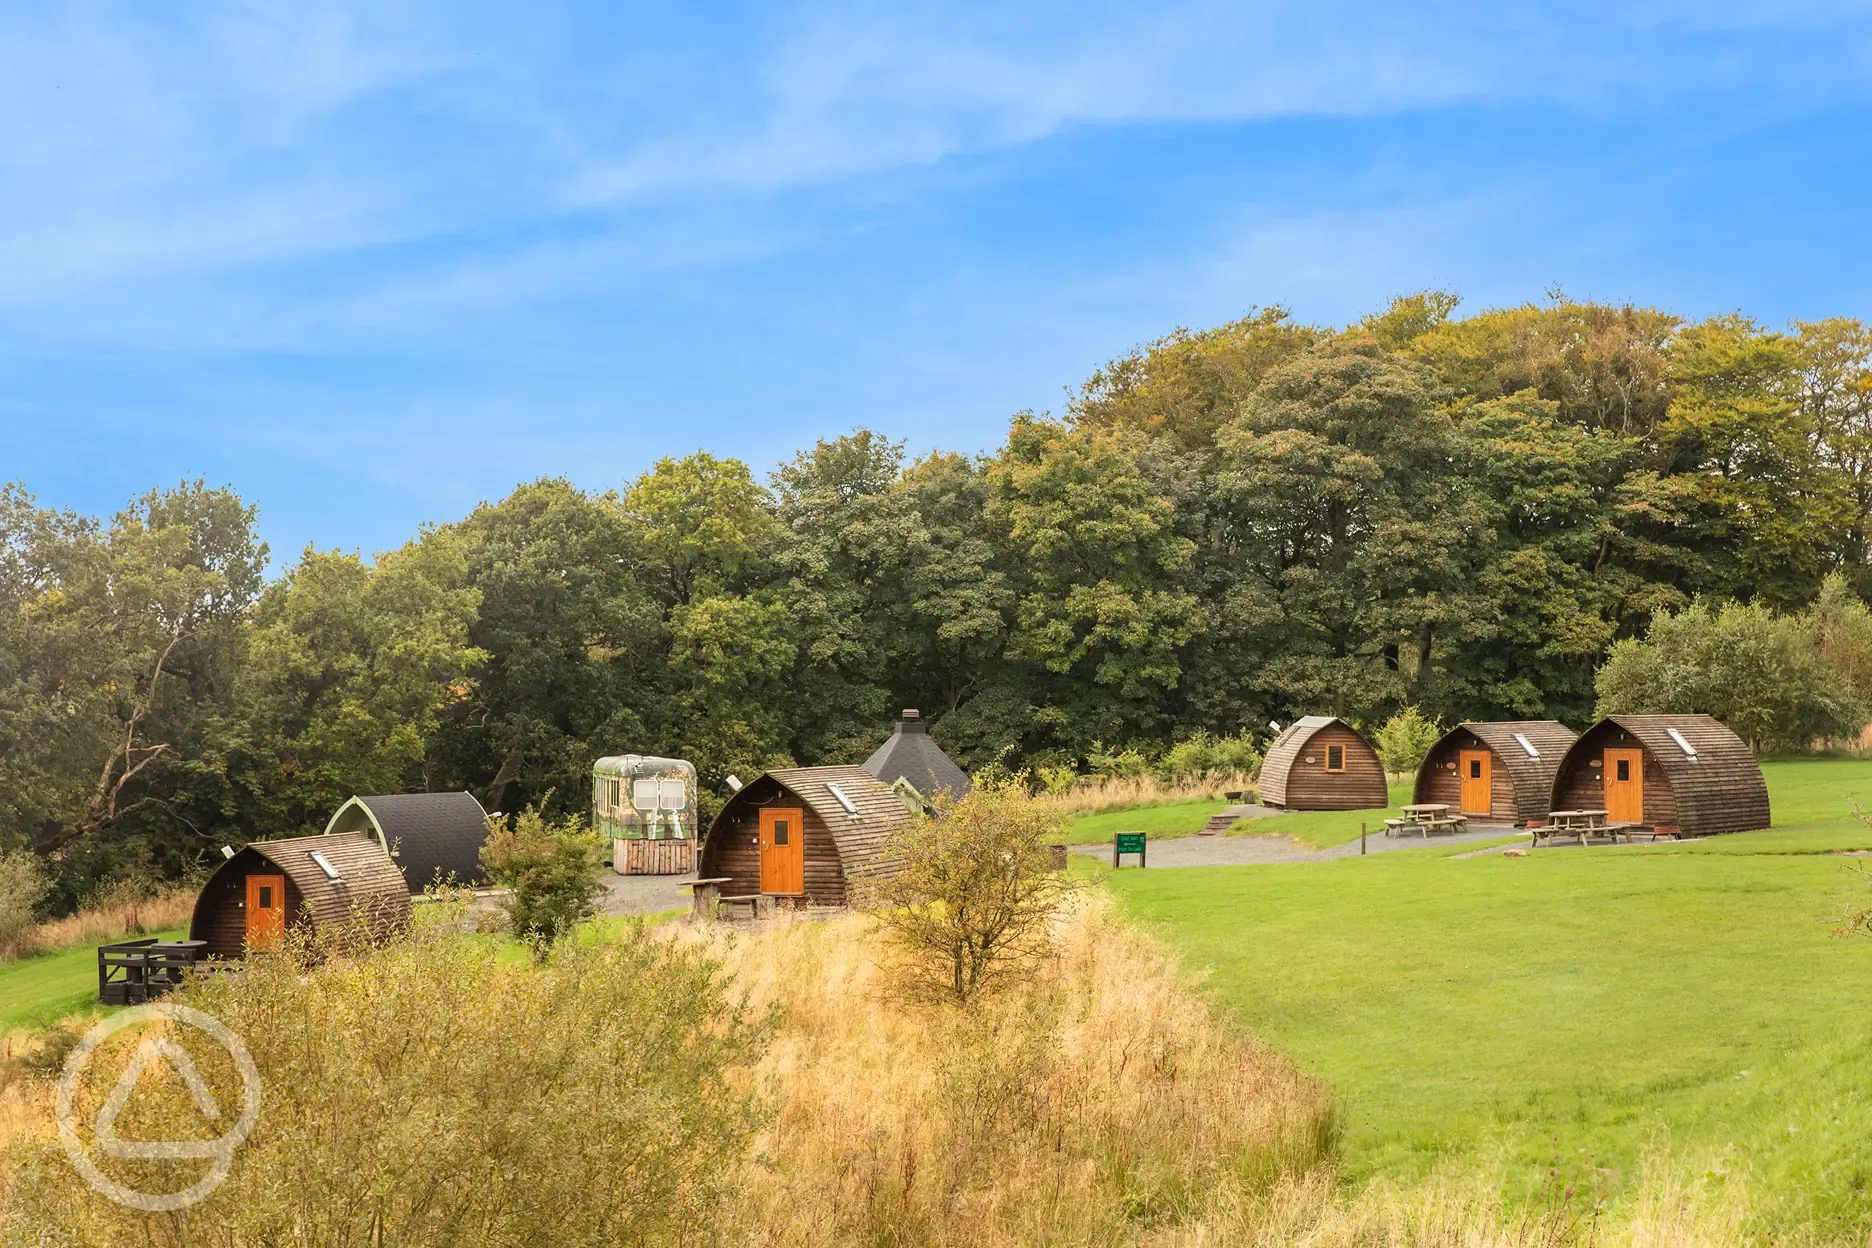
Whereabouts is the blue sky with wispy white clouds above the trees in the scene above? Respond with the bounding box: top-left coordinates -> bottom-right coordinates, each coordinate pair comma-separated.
0,0 -> 1872,559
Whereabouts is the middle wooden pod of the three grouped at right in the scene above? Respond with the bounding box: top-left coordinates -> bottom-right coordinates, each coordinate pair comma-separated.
1411,718 -> 1578,825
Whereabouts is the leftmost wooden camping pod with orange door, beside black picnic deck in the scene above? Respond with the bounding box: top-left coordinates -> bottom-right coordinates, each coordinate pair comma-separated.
189,833 -> 410,958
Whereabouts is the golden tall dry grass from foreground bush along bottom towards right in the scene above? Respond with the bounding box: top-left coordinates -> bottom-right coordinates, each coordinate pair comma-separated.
707,896 -> 1773,1248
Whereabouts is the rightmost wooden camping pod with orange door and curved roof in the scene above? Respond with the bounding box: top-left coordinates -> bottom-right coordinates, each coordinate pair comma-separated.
1552,715 -> 1769,836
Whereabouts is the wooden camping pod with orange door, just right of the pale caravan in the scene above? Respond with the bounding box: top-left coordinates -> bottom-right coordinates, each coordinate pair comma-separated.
698,767 -> 917,906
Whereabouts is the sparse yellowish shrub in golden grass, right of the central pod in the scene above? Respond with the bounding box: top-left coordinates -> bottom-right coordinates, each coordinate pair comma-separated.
859,776 -> 1067,1003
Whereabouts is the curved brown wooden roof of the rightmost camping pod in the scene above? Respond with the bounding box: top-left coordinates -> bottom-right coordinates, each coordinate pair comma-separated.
1552,715 -> 1771,836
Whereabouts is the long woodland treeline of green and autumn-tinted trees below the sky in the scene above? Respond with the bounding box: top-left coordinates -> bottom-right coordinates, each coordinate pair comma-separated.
0,294 -> 1872,902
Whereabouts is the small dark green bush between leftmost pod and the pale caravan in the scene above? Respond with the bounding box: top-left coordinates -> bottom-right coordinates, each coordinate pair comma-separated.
481,801 -> 603,958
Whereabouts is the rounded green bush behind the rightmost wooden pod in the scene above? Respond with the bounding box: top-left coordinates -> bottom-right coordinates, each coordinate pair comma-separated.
1595,602 -> 1866,748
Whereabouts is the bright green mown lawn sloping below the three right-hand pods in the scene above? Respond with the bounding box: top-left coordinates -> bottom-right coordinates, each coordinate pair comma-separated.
1106,760 -> 1872,1229
